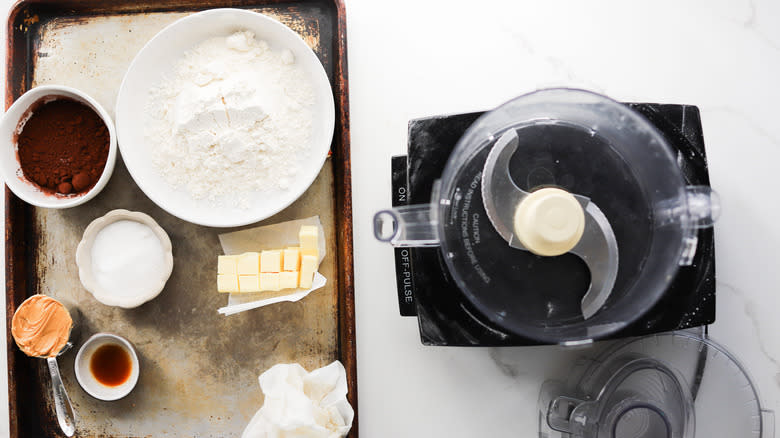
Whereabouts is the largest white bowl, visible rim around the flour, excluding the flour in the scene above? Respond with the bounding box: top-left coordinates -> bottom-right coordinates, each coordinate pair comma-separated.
116,9 -> 335,227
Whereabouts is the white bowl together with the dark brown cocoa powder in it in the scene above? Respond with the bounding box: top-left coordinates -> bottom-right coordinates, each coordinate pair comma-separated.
0,85 -> 117,208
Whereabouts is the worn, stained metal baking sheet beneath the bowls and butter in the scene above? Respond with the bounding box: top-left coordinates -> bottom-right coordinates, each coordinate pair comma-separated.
7,3 -> 357,437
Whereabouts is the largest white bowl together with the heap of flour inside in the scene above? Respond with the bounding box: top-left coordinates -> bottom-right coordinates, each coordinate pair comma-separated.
116,9 -> 335,227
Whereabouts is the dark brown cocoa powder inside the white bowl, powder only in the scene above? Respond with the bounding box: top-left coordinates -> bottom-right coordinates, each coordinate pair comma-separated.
16,98 -> 109,194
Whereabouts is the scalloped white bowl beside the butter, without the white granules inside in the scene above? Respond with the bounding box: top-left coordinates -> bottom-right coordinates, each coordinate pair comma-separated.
76,210 -> 173,309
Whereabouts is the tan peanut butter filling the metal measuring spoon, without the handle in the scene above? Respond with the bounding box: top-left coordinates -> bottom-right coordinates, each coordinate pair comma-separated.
11,295 -> 73,357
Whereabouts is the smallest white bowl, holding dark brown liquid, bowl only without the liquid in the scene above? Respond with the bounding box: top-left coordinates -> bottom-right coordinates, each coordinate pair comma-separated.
73,333 -> 141,401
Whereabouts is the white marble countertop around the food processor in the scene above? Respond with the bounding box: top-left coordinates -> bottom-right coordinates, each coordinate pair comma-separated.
0,0 -> 780,438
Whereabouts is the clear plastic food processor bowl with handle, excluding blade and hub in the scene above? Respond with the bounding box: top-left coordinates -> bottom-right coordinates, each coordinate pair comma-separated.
374,89 -> 720,344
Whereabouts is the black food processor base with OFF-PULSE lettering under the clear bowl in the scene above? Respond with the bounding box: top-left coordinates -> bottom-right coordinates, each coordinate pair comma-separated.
392,103 -> 715,346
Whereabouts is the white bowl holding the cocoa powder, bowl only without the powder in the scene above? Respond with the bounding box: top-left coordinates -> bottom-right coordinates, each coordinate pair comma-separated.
0,85 -> 116,208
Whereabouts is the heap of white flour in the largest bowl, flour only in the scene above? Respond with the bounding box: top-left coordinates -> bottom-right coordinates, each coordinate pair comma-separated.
145,31 -> 314,208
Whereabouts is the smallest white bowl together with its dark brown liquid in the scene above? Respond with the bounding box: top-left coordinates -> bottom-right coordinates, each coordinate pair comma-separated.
74,333 -> 140,401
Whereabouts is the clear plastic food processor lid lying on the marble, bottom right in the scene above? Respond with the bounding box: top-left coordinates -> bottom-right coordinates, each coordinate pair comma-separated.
547,332 -> 774,438
